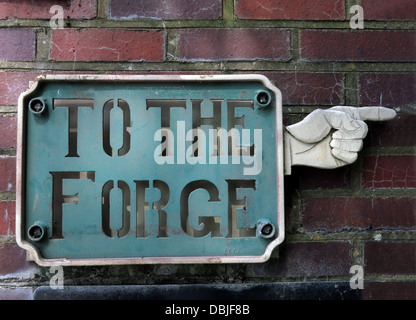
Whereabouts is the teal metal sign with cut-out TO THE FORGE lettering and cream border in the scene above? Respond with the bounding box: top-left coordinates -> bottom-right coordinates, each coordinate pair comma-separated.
16,75 -> 284,265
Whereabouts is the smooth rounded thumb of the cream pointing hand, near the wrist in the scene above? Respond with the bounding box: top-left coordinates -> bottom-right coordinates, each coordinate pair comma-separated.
286,109 -> 332,143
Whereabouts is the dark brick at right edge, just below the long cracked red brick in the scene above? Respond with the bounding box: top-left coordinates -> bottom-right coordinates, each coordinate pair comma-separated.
364,241 -> 416,275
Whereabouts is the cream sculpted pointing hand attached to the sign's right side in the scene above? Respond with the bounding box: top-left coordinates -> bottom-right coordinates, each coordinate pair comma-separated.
285,106 -> 396,174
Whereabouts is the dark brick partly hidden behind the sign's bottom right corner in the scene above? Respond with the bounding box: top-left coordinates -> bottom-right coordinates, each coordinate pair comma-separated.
248,242 -> 350,277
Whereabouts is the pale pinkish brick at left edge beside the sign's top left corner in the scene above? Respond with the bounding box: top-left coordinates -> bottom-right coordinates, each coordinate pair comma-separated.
0,71 -> 39,106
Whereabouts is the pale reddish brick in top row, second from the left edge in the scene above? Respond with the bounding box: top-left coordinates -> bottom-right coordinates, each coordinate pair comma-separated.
110,0 -> 222,20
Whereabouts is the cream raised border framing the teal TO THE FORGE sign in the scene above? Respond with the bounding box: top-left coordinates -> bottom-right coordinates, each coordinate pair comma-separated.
16,74 -> 285,266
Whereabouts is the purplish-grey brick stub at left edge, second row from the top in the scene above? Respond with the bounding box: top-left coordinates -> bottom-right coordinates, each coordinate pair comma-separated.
0,29 -> 36,61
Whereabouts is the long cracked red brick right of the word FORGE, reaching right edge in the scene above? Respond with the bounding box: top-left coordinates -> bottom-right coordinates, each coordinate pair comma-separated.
301,198 -> 416,231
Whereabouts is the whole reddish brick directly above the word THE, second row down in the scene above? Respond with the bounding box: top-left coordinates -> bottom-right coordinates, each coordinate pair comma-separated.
179,28 -> 290,61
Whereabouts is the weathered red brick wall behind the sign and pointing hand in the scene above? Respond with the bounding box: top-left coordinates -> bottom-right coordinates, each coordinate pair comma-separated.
0,0 -> 416,299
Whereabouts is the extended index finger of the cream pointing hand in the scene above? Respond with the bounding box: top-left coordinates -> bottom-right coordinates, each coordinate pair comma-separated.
331,106 -> 396,121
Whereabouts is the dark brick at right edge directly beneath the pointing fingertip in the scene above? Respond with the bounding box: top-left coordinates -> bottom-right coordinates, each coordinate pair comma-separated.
364,113 -> 416,147
